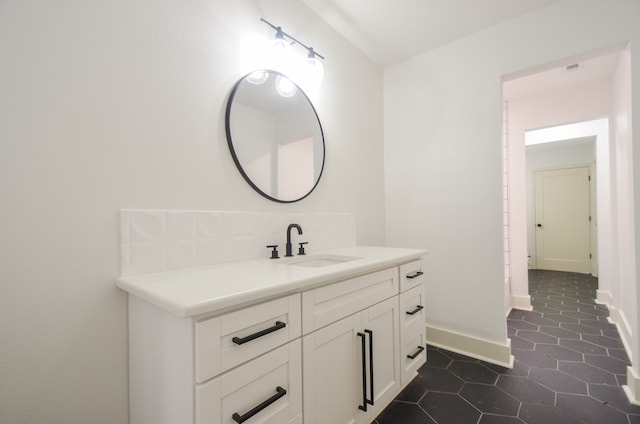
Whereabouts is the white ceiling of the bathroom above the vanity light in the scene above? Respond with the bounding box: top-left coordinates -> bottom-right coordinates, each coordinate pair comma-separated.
302,0 -> 560,66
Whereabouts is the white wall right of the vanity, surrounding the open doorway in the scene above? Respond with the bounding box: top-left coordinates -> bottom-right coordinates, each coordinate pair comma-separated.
384,0 -> 640,364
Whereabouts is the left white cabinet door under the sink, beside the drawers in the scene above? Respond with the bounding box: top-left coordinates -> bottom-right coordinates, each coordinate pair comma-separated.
302,314 -> 362,424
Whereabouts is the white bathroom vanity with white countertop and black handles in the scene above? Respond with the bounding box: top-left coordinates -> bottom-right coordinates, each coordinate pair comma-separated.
117,247 -> 426,424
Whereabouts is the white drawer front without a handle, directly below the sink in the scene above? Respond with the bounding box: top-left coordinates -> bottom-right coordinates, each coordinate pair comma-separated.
302,268 -> 398,334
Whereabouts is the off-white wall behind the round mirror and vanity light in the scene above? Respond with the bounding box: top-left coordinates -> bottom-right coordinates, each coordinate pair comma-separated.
0,0 -> 384,424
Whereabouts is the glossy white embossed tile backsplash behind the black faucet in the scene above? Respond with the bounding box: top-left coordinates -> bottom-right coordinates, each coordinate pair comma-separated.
120,209 -> 356,277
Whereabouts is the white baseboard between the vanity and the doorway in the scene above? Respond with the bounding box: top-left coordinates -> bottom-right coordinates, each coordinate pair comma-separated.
427,325 -> 513,368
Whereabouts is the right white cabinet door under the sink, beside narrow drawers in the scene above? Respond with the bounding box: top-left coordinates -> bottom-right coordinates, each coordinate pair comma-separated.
362,296 -> 400,416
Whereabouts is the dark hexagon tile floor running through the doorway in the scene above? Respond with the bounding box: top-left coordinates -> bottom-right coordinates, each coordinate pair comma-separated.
374,270 -> 640,424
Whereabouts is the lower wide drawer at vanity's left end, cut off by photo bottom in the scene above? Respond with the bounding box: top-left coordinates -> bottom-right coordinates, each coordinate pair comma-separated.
195,339 -> 302,424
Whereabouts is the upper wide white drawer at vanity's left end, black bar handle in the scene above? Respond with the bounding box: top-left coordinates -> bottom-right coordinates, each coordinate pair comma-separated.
195,294 -> 301,383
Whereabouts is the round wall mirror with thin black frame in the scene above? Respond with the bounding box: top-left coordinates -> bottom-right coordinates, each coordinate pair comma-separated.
225,70 -> 324,203
